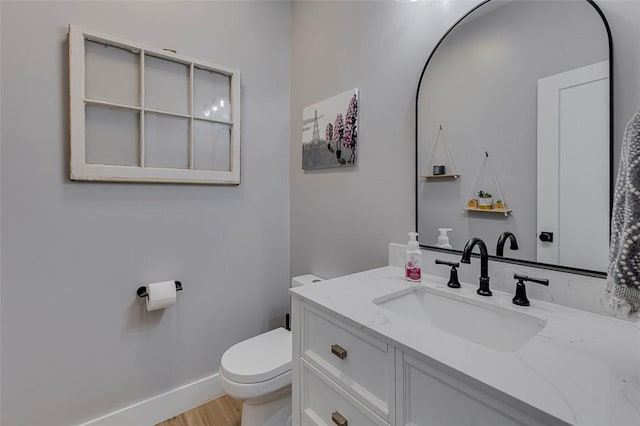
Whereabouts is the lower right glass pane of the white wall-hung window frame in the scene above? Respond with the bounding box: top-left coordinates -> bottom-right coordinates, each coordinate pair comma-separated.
193,120 -> 231,171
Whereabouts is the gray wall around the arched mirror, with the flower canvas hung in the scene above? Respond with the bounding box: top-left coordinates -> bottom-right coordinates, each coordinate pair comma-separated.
291,0 -> 640,277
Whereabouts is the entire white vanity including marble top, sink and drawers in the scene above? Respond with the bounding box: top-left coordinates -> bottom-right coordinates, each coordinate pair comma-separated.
290,266 -> 640,426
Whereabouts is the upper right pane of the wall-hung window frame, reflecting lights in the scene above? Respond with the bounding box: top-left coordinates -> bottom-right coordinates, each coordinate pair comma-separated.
193,68 -> 231,121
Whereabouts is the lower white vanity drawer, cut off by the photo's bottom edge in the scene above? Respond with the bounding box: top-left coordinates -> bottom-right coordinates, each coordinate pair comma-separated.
300,360 -> 388,426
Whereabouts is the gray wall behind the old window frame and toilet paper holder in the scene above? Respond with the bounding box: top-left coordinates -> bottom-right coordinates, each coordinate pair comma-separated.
1,1 -> 290,426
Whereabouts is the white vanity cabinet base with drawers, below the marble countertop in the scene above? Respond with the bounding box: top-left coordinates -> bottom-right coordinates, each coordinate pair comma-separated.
292,297 -> 564,426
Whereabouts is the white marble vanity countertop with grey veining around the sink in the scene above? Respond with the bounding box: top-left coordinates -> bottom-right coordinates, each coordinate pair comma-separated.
291,266 -> 640,426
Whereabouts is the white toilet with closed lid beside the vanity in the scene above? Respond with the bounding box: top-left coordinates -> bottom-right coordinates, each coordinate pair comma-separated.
219,275 -> 321,426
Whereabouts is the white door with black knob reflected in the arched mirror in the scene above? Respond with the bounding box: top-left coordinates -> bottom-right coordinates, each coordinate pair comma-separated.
537,61 -> 610,271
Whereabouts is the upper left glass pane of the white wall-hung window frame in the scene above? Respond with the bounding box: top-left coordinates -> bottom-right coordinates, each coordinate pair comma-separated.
84,40 -> 140,106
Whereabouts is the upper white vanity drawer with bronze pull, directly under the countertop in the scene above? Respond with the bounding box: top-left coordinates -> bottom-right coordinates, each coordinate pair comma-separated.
302,306 -> 395,420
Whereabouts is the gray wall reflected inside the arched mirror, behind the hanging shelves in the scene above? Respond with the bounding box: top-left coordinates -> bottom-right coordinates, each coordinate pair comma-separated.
418,1 -> 609,262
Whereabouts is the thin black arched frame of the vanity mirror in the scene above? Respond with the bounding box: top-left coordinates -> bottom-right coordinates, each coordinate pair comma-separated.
414,0 -> 615,278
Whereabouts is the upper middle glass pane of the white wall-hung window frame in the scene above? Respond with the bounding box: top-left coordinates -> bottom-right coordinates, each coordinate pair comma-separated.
144,56 -> 189,114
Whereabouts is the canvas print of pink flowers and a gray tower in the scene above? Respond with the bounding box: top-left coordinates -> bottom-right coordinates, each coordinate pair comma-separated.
302,89 -> 359,170
